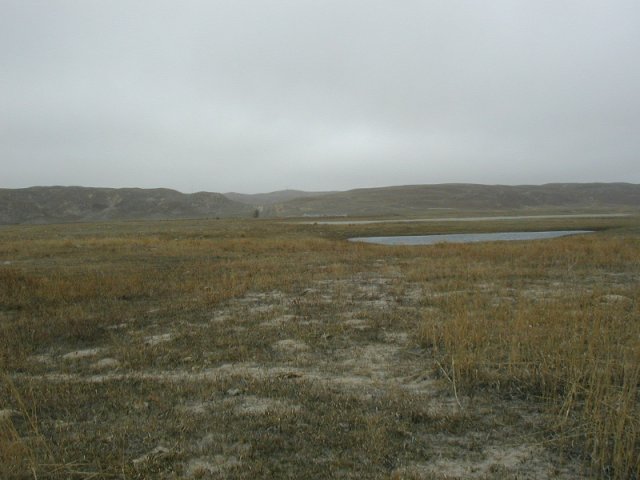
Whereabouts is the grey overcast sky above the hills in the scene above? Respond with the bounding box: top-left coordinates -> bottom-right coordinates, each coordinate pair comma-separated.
0,0 -> 640,193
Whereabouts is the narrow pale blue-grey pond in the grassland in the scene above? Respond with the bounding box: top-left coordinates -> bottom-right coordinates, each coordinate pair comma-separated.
349,230 -> 593,245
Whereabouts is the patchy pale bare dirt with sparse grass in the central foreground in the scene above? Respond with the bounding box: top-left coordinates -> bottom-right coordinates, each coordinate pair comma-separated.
10,276 -> 588,479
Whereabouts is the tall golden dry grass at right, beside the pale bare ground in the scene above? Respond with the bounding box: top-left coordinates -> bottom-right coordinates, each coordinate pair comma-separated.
420,236 -> 640,479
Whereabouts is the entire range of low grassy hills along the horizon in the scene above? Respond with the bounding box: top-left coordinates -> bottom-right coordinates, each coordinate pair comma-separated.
0,183 -> 640,224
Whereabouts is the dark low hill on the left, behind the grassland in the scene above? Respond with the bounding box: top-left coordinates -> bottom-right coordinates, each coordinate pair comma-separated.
0,187 -> 253,224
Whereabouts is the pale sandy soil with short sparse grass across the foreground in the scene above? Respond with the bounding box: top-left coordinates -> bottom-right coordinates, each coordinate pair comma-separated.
15,272 -> 588,479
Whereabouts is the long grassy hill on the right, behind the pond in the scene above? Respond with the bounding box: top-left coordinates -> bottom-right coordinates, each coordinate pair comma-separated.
264,183 -> 640,216
